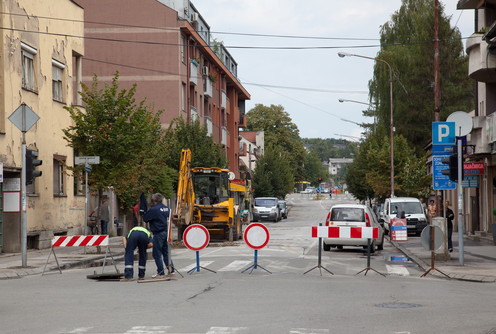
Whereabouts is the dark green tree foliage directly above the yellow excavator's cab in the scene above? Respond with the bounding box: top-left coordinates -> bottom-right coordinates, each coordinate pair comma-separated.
162,118 -> 228,170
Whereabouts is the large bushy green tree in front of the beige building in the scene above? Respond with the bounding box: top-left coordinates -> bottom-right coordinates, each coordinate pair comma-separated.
63,73 -> 174,209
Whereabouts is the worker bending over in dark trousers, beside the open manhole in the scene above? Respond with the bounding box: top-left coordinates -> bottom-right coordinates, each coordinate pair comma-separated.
122,226 -> 153,281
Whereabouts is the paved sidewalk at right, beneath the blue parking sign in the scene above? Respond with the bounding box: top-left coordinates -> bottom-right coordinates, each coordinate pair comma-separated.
391,232 -> 496,282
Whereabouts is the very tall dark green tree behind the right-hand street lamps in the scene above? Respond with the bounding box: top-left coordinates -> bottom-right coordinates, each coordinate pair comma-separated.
369,0 -> 473,153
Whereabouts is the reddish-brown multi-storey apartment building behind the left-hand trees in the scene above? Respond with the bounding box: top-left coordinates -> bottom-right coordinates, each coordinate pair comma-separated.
76,0 -> 250,177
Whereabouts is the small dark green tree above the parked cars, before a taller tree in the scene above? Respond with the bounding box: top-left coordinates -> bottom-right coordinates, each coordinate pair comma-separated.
252,146 -> 294,199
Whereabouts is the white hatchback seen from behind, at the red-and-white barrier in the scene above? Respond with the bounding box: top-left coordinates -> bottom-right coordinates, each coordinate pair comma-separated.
323,204 -> 384,253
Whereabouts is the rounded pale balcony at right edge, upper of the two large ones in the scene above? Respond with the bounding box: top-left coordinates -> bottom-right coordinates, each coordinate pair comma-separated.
467,33 -> 496,83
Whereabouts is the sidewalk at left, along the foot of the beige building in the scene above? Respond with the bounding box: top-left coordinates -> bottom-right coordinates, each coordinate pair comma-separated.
0,237 -> 124,279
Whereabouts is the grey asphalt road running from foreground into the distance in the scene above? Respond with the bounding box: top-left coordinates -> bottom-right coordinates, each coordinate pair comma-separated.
0,195 -> 496,334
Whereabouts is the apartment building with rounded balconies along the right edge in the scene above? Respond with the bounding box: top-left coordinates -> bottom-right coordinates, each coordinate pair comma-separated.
447,0 -> 496,235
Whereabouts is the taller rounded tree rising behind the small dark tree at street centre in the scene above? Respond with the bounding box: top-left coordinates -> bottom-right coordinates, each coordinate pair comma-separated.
246,104 -> 305,180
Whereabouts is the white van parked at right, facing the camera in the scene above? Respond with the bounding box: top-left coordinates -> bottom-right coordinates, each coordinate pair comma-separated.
382,197 -> 427,235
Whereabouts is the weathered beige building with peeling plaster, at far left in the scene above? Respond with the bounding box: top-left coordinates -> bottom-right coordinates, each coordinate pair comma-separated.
0,0 -> 85,252
